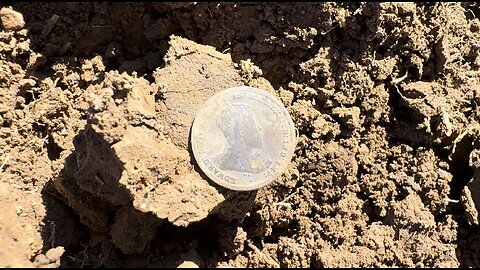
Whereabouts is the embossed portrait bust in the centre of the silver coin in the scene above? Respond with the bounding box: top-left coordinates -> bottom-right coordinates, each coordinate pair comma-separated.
217,105 -> 266,173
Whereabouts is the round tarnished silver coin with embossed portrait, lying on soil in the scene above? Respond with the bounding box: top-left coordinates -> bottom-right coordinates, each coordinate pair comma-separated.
191,86 -> 297,191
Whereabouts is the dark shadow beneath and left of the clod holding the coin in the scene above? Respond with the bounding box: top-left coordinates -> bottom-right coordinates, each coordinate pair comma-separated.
42,125 -> 256,267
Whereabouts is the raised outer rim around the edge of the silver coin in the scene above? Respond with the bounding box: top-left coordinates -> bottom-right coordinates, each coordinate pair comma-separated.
190,86 -> 297,191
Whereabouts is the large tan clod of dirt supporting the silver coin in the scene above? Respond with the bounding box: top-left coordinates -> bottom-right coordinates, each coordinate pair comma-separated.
55,36 -> 273,254
